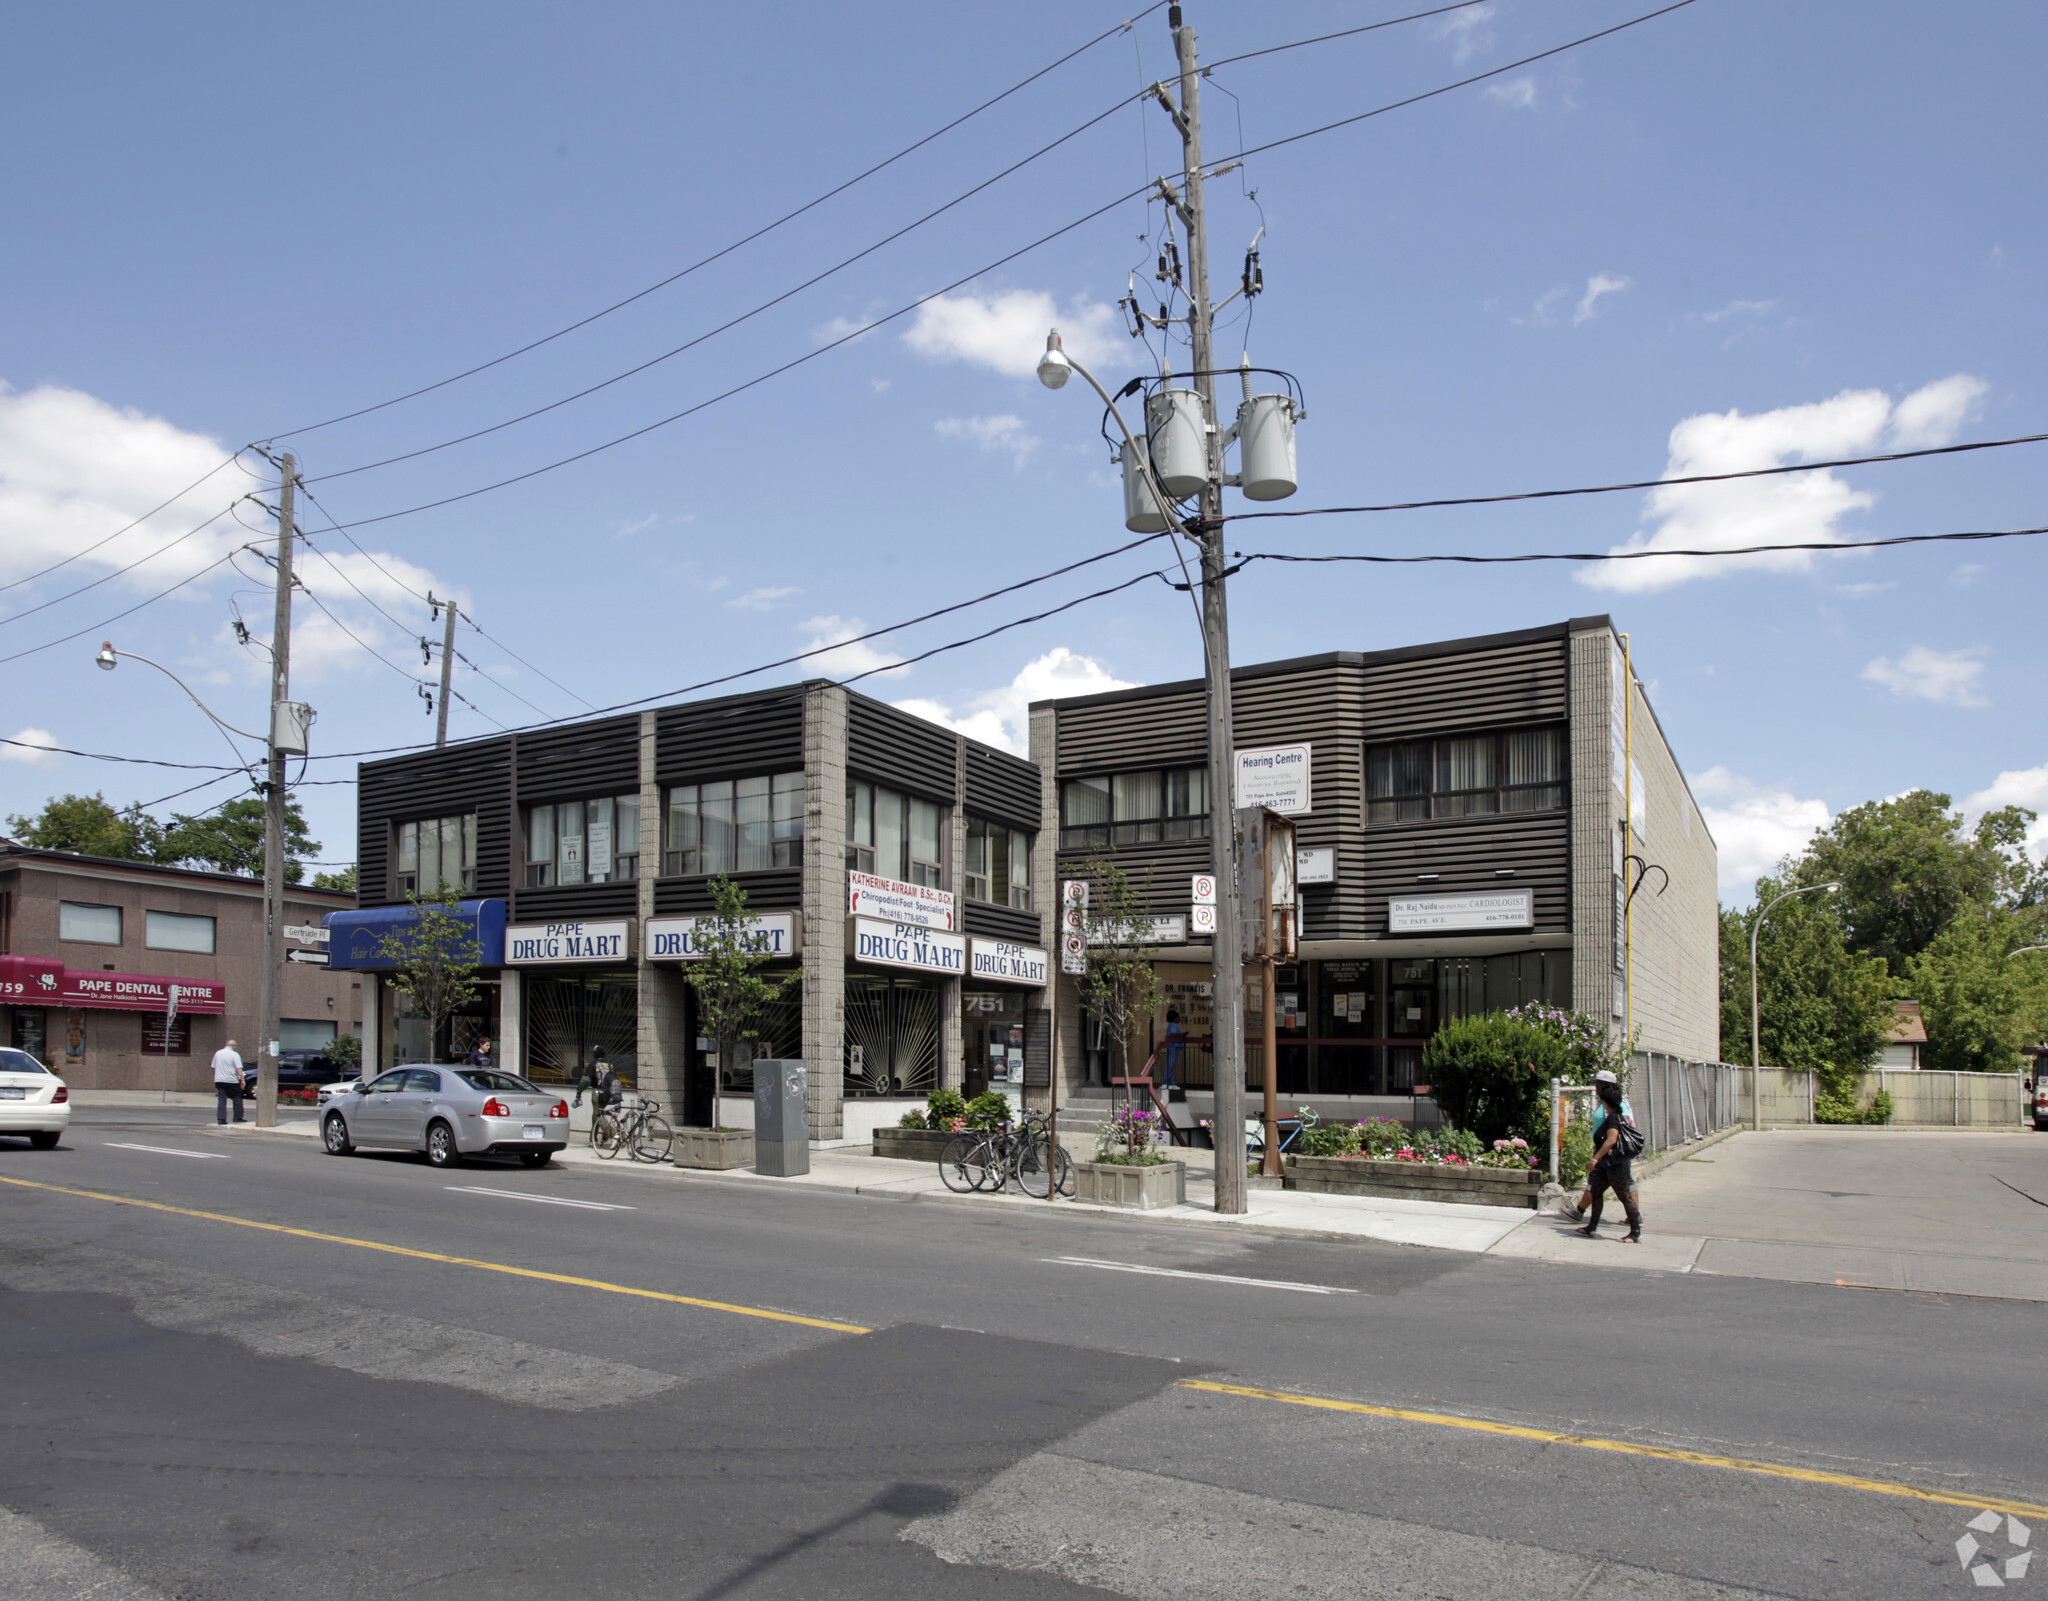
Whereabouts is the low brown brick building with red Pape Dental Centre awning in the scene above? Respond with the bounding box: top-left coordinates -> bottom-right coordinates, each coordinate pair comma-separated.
0,839 -> 362,1091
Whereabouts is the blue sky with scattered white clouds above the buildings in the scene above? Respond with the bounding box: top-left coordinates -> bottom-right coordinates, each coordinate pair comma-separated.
0,0 -> 2048,895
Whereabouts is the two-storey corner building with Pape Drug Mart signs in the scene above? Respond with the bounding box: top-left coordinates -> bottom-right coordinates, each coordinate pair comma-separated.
330,682 -> 1051,1140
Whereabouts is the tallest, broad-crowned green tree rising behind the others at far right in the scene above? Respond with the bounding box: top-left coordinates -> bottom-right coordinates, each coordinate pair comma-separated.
1802,790 -> 2048,975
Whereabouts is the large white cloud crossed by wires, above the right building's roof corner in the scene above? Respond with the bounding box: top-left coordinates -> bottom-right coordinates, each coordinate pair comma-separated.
1579,379 -> 1976,592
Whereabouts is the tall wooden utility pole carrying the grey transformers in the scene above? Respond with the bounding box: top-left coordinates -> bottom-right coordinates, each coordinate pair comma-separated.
1161,6 -> 1245,1212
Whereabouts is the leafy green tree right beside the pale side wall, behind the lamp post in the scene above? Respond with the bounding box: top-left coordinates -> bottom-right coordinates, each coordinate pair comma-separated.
1720,878 -> 1892,1087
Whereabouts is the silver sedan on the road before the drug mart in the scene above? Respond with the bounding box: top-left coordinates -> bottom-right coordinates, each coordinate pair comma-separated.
319,1067 -> 569,1167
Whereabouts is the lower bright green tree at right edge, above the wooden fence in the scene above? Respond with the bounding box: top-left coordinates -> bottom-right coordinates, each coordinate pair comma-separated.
1907,907 -> 2048,1073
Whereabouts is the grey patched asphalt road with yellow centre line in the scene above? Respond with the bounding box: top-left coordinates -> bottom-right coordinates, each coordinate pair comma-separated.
0,1108 -> 2048,1601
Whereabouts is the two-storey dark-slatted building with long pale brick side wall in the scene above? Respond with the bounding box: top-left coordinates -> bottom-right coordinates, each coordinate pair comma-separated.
1030,616 -> 1718,1114
